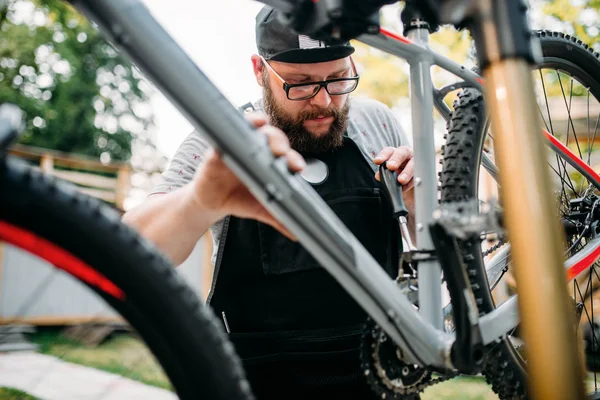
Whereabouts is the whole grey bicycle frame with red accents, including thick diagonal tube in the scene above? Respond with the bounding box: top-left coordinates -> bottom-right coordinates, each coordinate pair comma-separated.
70,0 -> 600,369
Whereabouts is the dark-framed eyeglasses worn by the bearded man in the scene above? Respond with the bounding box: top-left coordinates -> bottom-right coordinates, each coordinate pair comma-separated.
261,57 -> 359,100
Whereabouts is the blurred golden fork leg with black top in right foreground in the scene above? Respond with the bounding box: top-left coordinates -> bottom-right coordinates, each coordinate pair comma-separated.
471,0 -> 584,400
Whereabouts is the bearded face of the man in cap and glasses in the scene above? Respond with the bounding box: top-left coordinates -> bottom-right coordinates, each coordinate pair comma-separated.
261,58 -> 354,154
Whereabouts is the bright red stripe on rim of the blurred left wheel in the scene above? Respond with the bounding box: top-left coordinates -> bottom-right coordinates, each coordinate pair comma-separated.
0,221 -> 125,301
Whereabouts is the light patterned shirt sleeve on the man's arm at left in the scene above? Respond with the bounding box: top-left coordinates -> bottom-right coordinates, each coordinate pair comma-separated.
150,131 -> 210,195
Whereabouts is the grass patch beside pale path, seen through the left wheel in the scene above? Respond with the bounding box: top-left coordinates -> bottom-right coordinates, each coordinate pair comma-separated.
29,331 -> 173,392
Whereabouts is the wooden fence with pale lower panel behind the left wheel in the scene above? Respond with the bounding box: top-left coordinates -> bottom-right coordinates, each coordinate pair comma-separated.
0,145 -> 131,325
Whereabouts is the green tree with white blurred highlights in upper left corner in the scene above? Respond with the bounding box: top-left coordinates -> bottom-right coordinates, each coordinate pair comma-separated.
0,0 -> 153,162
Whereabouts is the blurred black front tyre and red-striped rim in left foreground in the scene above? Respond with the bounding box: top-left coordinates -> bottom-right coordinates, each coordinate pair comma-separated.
0,158 -> 252,400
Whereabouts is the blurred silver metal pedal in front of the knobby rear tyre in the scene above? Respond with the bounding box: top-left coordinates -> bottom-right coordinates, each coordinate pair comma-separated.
433,200 -> 504,240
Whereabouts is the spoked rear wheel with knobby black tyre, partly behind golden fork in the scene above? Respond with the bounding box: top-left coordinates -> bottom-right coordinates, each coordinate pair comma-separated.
440,31 -> 600,399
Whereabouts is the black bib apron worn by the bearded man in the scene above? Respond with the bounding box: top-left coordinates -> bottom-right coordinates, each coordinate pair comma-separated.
209,137 -> 400,400
